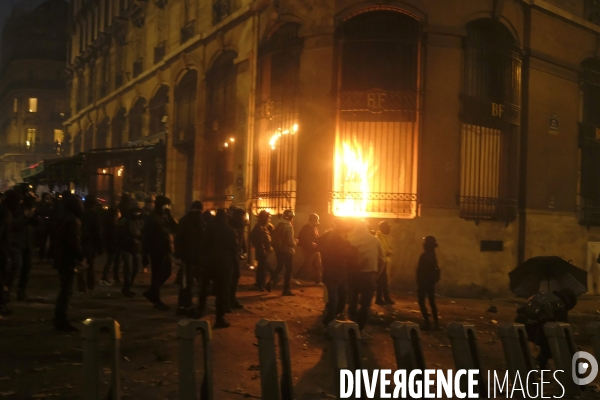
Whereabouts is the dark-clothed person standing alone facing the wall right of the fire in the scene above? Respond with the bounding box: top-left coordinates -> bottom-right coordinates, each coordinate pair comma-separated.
417,236 -> 440,331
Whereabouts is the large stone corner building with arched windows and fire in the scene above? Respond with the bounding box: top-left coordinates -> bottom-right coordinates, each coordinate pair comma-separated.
66,0 -> 600,295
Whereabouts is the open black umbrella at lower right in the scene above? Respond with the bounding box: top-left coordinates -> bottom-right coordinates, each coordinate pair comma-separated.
508,256 -> 587,298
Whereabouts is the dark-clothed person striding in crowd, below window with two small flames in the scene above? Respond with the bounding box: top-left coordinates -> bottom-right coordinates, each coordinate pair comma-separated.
198,210 -> 239,328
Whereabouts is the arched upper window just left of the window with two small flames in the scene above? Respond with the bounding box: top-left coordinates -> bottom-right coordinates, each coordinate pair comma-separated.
174,69 -> 198,141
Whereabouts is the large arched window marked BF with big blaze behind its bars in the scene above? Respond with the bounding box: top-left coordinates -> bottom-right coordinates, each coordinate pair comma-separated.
331,10 -> 421,218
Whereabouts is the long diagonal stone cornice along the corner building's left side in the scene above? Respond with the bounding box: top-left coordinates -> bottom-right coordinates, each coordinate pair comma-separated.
64,3 -> 256,126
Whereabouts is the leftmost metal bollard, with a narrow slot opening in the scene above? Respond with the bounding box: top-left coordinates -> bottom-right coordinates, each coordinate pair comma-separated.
81,318 -> 121,400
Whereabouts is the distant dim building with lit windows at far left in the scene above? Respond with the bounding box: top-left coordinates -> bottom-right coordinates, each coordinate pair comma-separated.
0,0 -> 69,190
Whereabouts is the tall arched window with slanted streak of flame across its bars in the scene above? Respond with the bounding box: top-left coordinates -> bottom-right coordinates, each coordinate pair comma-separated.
253,23 -> 302,213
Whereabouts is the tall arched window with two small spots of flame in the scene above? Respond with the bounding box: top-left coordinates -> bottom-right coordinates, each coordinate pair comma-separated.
203,52 -> 237,208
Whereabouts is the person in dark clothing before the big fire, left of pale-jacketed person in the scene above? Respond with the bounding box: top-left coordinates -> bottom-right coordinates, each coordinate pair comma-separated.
317,218 -> 353,325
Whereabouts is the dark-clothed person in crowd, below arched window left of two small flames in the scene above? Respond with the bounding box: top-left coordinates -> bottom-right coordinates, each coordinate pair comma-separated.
175,201 -> 206,316
